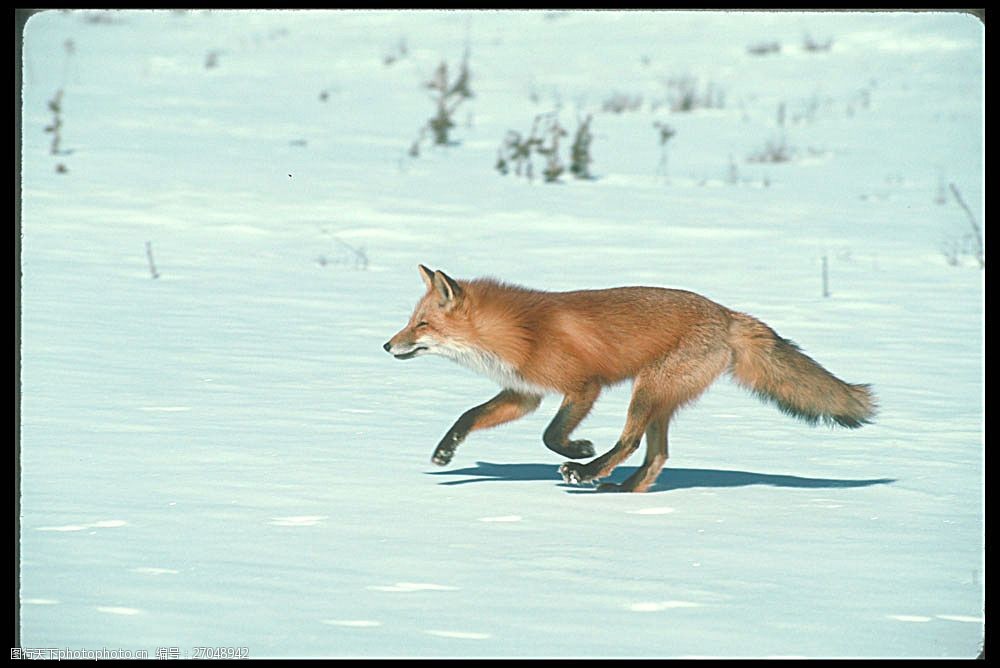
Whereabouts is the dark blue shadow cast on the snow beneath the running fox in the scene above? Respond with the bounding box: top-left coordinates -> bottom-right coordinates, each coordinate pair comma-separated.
427,462 -> 896,492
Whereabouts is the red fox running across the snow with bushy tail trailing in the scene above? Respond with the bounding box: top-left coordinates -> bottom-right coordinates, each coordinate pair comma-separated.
383,265 -> 876,492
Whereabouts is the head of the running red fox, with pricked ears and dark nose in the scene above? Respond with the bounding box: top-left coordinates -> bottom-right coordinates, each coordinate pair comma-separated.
382,265 -> 467,360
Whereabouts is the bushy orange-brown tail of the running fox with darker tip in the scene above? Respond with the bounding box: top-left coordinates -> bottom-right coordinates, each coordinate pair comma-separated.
729,312 -> 876,429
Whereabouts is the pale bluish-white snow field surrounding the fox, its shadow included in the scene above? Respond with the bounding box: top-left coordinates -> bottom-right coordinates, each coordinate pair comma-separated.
20,12 -> 985,657
